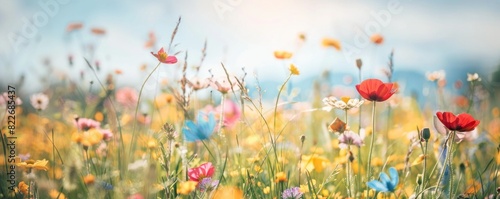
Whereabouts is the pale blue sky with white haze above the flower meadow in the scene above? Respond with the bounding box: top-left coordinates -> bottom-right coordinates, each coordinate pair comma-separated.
0,0 -> 500,93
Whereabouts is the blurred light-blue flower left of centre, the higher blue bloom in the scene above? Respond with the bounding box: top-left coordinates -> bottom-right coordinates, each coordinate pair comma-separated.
182,113 -> 216,142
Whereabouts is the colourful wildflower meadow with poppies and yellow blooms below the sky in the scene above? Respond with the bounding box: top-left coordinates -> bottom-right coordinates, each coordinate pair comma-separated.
0,1 -> 500,199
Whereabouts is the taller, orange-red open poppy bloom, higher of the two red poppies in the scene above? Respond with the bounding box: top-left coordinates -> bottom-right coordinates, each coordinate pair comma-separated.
356,79 -> 397,102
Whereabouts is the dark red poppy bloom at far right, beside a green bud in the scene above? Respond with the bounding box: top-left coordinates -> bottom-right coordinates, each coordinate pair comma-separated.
436,112 -> 479,132
